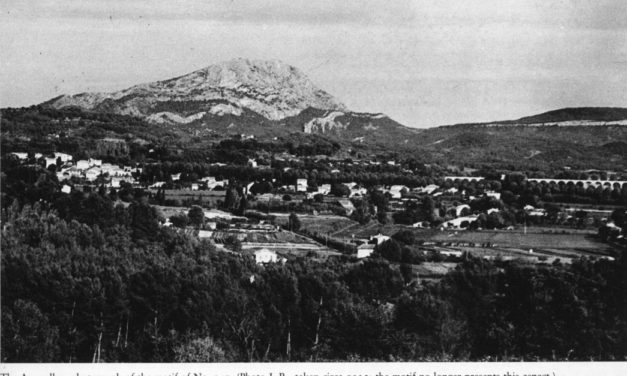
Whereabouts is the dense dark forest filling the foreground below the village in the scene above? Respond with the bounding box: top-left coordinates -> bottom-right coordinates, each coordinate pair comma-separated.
1,204 -> 627,362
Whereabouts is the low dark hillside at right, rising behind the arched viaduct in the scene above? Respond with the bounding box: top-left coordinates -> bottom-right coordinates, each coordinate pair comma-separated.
416,107 -> 627,169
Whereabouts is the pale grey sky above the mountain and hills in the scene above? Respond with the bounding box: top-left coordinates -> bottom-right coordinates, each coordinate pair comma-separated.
0,0 -> 627,127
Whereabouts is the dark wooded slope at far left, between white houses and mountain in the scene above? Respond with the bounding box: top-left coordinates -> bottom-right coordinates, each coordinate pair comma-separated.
1,106 -> 178,165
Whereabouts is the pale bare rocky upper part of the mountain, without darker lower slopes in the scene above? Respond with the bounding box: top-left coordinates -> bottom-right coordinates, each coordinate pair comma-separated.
48,58 -> 346,122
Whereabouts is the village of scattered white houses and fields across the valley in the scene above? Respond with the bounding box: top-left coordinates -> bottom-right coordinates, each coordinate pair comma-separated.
12,148 -> 627,278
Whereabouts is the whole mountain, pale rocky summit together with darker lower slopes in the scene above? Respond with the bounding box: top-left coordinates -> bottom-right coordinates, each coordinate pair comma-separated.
44,59 -> 416,142
